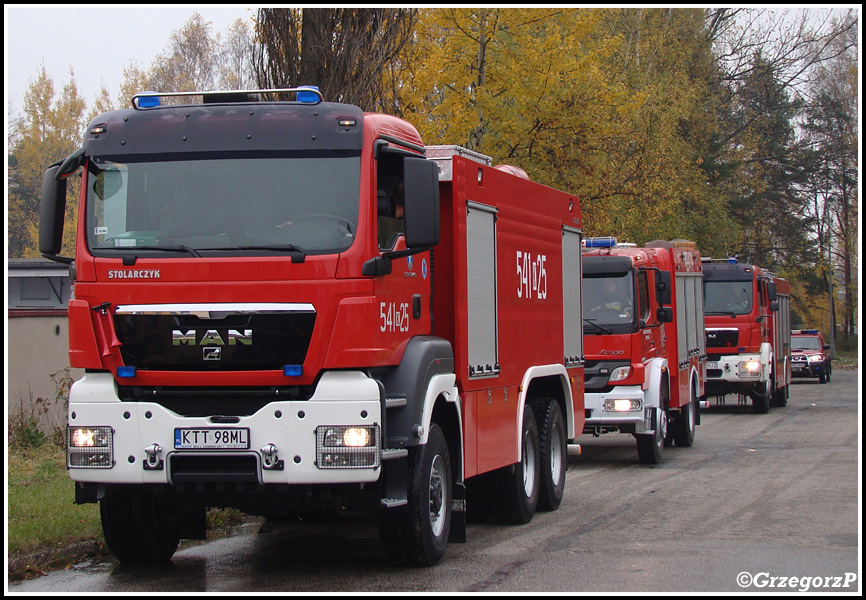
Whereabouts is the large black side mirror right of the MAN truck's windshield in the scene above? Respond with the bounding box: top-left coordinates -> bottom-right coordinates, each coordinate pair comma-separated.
403,157 -> 439,248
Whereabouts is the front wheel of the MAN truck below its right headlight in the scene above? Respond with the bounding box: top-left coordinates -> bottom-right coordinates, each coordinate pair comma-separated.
379,423 -> 452,567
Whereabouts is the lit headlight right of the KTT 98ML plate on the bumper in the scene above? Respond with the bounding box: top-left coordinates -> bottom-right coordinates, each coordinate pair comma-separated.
316,425 -> 381,469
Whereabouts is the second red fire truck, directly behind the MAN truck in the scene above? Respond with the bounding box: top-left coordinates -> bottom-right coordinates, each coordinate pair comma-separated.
583,238 -> 706,464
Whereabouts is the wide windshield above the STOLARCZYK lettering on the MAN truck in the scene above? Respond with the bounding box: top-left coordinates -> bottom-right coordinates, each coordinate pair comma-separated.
87,156 -> 361,256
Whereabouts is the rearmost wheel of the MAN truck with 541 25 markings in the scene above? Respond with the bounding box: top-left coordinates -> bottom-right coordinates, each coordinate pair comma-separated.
537,400 -> 568,511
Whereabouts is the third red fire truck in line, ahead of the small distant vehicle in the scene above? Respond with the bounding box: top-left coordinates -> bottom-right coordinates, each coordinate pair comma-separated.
704,258 -> 791,413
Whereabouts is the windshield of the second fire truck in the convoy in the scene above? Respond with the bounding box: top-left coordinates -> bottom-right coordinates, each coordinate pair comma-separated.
583,272 -> 634,334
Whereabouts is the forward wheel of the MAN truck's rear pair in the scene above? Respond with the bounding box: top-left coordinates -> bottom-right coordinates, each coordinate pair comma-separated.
492,406 -> 541,525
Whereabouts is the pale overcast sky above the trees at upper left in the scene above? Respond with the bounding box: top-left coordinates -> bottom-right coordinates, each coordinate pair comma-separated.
4,4 -> 251,118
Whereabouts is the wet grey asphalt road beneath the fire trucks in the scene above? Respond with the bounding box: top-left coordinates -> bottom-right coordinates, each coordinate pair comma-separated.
7,370 -> 862,594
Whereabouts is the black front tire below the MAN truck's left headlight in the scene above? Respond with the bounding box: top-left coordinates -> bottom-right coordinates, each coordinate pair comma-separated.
99,485 -> 181,565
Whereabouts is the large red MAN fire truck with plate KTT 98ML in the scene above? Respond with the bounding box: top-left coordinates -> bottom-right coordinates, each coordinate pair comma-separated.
40,88 -> 584,565
